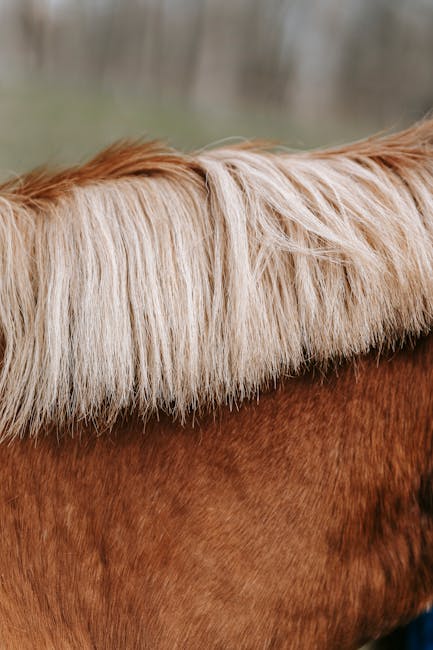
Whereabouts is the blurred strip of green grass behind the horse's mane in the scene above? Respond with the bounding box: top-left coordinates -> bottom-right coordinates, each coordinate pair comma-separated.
0,81 -> 377,178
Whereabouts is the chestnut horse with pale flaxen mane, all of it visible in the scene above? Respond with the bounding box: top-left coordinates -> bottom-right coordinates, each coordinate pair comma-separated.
0,120 -> 433,650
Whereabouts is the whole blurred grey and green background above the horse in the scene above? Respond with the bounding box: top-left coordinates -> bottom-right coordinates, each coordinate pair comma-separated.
0,0 -> 433,177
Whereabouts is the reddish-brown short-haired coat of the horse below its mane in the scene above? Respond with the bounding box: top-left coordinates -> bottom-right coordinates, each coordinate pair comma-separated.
0,337 -> 433,650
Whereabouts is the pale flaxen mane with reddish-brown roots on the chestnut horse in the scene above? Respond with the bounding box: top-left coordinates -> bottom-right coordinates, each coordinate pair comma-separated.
0,120 -> 433,438
